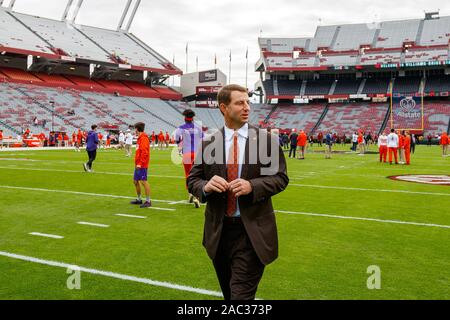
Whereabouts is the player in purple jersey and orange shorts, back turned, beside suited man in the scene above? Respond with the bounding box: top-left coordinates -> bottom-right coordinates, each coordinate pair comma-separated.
175,109 -> 203,208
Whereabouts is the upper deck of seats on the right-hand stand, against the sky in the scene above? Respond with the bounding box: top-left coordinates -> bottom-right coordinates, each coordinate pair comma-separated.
255,14 -> 450,72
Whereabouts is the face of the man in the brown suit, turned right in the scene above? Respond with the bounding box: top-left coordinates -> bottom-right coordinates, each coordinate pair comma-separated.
220,91 -> 250,125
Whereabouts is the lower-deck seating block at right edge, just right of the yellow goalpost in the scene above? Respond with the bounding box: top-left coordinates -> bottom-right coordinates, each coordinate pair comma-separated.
424,101 -> 450,135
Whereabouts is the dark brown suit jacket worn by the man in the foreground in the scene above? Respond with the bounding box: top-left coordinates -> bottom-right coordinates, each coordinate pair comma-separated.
187,126 -> 289,265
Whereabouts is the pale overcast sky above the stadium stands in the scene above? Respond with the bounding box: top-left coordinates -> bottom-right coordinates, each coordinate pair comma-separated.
4,0 -> 450,88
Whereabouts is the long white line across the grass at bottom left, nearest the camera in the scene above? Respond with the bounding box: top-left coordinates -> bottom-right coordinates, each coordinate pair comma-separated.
0,251 -> 223,297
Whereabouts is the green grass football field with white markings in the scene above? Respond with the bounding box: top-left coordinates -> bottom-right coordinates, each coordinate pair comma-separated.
0,146 -> 450,299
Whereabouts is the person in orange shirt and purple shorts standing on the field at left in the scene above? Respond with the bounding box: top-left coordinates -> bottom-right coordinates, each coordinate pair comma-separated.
130,122 -> 152,208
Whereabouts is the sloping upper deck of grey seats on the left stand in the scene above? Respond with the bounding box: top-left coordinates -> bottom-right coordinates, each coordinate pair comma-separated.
0,7 -> 182,79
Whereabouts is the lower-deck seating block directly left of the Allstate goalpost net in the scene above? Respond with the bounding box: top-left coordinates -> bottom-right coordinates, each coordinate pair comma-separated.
316,103 -> 388,136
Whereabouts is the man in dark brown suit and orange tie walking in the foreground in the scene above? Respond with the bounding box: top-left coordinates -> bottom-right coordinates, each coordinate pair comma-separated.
188,85 -> 289,300
